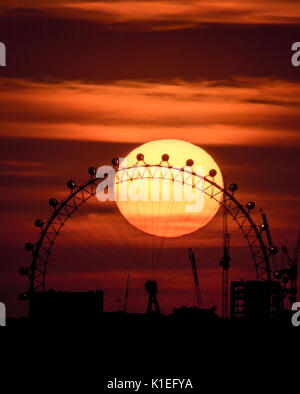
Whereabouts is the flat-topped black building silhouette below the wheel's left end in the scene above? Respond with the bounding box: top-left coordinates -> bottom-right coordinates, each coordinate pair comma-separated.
29,290 -> 103,325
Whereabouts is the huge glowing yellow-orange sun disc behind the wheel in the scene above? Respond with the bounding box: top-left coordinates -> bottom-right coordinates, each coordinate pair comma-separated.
115,140 -> 223,237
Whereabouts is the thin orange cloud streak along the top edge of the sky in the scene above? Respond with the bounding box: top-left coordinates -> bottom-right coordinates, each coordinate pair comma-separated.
0,0 -> 300,29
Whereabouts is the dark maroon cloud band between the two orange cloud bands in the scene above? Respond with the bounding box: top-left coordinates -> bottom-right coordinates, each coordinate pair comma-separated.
0,16 -> 300,82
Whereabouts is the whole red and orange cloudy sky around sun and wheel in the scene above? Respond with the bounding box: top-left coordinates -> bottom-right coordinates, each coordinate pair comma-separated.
0,0 -> 300,315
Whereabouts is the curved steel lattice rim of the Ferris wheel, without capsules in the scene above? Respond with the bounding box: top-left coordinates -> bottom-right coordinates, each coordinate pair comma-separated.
22,164 -> 272,292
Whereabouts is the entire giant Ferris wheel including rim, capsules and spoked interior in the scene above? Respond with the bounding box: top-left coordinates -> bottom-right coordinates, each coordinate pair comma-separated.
20,143 -> 277,311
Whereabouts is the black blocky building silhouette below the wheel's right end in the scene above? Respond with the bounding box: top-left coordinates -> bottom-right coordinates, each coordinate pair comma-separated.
231,281 -> 283,320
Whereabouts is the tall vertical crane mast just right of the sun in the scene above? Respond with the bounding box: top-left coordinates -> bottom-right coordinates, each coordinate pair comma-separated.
219,195 -> 230,319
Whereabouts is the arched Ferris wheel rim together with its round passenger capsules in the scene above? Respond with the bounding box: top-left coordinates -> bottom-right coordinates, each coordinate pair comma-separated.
20,154 -> 277,312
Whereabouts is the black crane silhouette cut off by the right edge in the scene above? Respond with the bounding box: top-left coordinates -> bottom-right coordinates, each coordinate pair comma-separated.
274,229 -> 300,306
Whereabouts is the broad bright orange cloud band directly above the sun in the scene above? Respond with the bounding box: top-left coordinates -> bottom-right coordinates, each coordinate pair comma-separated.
0,78 -> 300,146
